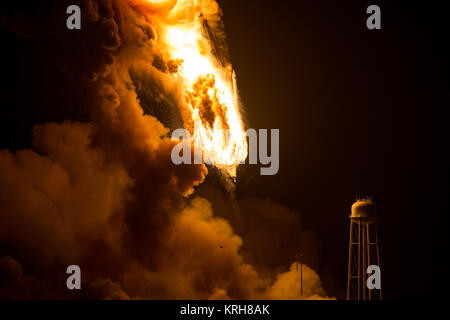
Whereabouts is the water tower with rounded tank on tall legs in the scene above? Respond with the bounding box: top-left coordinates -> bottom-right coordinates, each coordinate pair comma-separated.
347,198 -> 381,300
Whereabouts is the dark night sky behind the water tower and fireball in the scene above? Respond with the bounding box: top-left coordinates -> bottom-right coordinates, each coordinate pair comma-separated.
0,0 -> 442,299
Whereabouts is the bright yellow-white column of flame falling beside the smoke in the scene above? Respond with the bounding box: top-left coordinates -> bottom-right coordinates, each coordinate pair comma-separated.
142,0 -> 247,178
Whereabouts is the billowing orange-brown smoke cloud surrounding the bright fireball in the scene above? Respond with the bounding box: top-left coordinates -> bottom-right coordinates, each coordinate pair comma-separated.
0,0 -> 326,299
